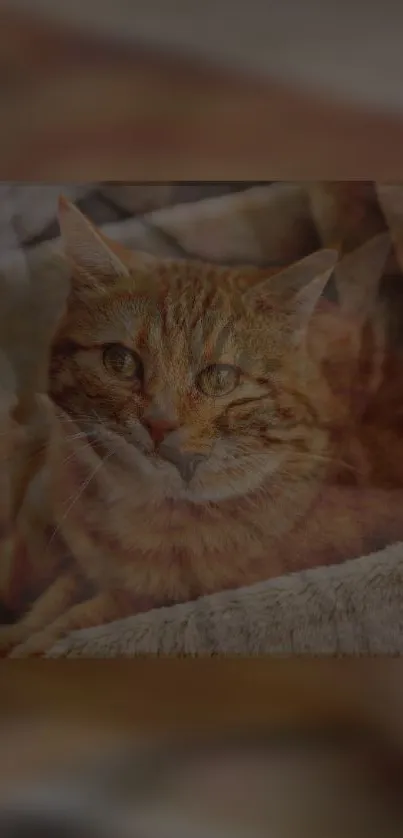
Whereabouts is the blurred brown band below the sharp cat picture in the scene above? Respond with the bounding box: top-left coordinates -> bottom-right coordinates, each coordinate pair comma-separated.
0,661 -> 403,838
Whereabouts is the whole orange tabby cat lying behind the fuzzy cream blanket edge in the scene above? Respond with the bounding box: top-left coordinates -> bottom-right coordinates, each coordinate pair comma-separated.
0,201 -> 395,655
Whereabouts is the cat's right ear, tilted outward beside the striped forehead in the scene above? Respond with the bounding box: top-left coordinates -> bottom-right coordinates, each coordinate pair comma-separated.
244,250 -> 339,335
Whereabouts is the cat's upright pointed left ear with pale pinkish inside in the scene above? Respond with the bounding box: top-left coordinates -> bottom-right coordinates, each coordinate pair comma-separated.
59,196 -> 130,290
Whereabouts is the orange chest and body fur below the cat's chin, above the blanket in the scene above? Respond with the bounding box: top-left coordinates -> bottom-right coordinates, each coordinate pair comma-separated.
11,426 -> 403,608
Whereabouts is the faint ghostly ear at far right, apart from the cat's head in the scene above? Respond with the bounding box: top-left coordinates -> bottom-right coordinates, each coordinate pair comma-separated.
334,233 -> 392,327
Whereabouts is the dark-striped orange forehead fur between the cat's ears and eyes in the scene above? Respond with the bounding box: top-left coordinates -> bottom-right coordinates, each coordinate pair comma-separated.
63,263 -> 294,369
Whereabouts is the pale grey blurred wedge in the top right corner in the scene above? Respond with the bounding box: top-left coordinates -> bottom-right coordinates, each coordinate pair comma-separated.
7,0 -> 403,112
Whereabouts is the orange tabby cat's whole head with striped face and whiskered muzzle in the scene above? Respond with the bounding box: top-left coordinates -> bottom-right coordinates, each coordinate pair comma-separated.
51,200 -> 336,502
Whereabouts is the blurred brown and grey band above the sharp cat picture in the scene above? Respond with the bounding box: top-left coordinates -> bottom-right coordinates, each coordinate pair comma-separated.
0,0 -> 403,181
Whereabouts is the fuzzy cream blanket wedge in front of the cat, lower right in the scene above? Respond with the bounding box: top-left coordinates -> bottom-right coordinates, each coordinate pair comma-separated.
47,543 -> 403,658
